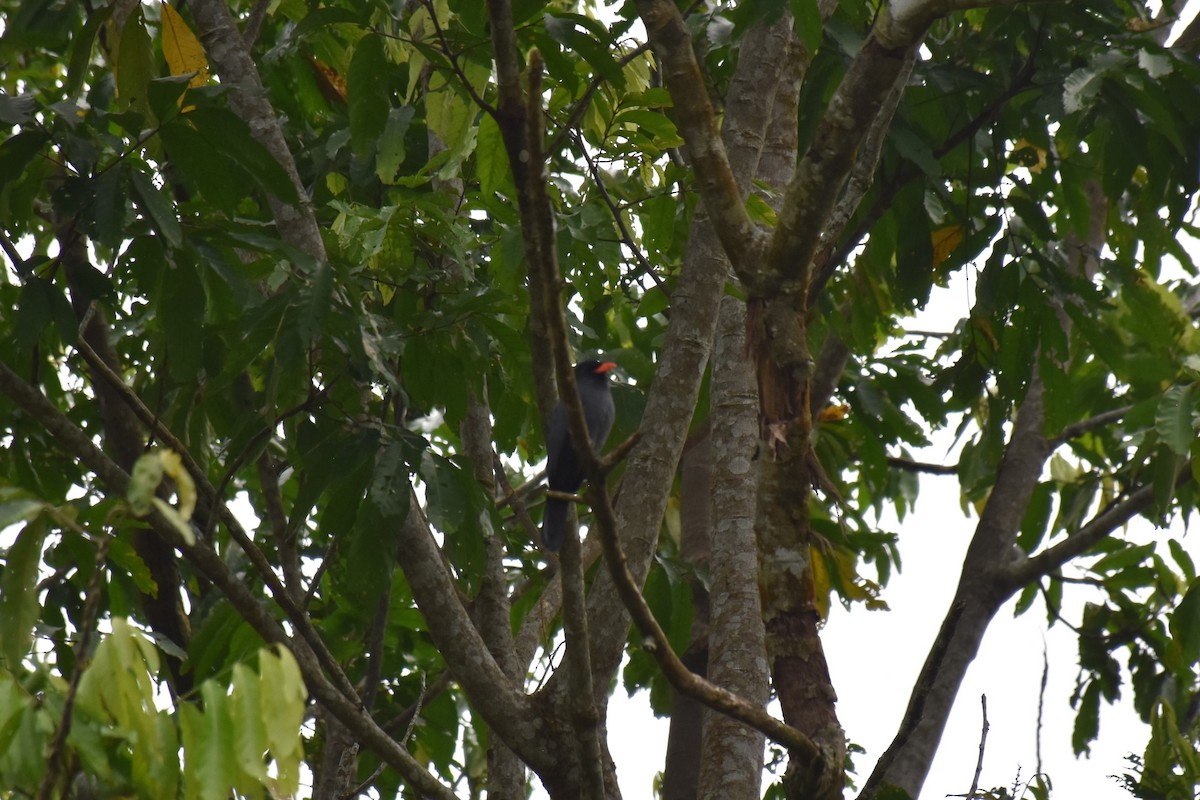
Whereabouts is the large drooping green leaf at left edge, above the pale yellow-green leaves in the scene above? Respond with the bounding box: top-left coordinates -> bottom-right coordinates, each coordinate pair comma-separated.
0,516 -> 49,673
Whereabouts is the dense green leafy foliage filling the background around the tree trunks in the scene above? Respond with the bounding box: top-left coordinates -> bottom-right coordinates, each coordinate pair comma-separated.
0,0 -> 1200,796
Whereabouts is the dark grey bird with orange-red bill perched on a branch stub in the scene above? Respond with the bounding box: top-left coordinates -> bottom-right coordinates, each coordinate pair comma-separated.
541,360 -> 617,553
